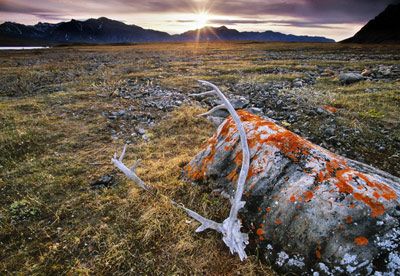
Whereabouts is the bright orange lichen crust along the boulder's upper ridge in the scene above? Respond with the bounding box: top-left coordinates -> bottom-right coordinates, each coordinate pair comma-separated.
185,109 -> 397,217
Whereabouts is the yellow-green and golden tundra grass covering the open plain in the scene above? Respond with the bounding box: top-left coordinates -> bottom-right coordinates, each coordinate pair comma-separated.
0,43 -> 400,275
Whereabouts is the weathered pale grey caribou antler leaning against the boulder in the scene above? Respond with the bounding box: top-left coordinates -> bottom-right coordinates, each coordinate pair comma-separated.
111,80 -> 250,261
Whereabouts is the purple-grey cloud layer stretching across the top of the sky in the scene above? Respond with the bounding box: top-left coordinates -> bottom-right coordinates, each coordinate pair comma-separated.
0,0 -> 400,25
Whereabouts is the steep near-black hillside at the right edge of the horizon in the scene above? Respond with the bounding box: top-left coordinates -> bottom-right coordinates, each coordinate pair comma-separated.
342,4 -> 400,43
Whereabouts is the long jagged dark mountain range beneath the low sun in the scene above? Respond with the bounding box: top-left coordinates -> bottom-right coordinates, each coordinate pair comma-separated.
0,17 -> 334,46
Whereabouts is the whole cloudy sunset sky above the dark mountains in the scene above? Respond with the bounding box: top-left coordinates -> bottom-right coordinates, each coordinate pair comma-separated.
0,0 -> 400,40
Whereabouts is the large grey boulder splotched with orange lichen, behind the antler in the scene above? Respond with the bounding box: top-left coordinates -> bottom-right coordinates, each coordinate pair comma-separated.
185,110 -> 400,275
